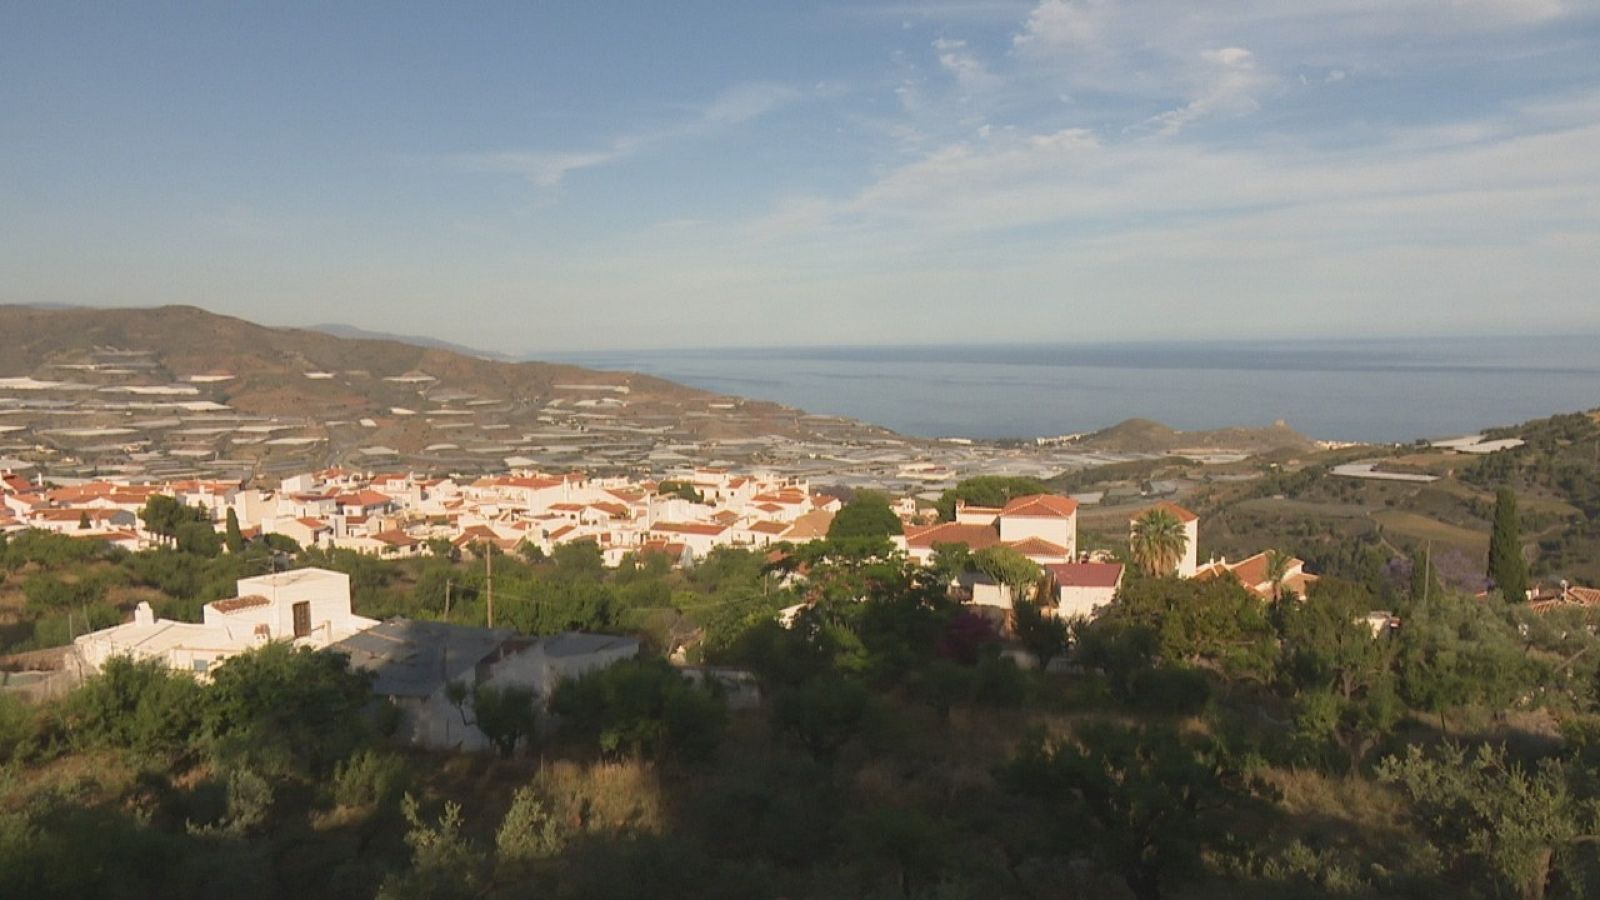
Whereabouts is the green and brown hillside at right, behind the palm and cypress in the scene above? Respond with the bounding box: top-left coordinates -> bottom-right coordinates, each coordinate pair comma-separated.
1048,406 -> 1600,591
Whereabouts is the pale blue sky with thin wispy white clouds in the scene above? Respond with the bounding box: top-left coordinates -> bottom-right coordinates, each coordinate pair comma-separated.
0,0 -> 1600,354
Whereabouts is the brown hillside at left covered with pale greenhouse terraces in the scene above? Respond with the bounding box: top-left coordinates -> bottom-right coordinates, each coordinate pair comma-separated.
0,306 -> 891,471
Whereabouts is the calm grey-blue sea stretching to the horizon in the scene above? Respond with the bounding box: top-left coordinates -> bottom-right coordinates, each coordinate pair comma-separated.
541,335 -> 1600,442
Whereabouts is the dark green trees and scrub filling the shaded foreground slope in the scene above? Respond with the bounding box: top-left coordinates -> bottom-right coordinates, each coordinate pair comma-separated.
9,509 -> 1600,898
